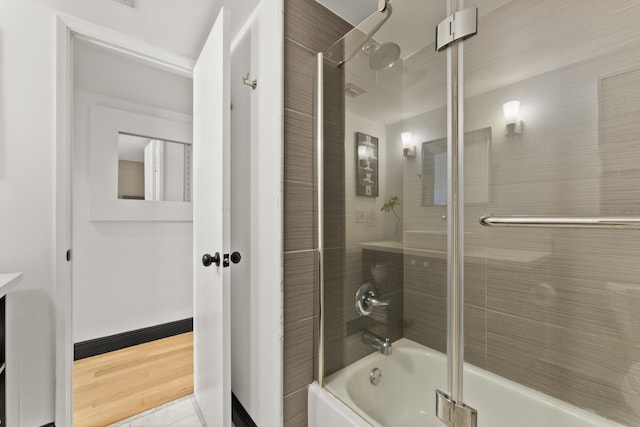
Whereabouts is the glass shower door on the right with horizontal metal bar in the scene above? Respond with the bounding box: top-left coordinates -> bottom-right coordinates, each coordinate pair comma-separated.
464,0 -> 640,426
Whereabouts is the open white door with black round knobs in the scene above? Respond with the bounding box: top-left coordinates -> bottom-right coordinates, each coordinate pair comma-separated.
193,8 -> 231,427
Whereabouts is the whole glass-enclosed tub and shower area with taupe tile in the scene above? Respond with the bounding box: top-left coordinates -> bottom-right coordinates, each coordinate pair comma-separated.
285,1 -> 640,426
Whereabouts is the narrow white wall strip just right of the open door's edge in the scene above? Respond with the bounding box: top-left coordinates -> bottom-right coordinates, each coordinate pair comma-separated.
231,22 -> 252,415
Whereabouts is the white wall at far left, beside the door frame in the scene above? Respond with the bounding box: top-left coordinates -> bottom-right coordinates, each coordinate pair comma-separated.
0,1 -> 55,426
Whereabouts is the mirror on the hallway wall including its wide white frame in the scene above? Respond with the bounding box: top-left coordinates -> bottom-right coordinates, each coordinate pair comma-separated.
90,105 -> 193,221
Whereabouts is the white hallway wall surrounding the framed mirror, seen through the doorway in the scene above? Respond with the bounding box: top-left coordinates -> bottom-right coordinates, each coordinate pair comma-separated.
72,40 -> 193,342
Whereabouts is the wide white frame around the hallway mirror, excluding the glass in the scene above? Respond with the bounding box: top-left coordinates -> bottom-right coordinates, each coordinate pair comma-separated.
90,105 -> 193,221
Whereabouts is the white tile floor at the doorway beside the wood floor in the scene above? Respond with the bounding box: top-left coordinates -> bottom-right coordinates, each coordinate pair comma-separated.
108,395 -> 204,427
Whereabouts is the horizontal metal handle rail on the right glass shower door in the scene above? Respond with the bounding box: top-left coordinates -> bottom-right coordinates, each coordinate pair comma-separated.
480,215 -> 640,229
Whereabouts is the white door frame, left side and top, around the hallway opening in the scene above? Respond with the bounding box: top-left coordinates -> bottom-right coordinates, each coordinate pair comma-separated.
53,13 -> 195,426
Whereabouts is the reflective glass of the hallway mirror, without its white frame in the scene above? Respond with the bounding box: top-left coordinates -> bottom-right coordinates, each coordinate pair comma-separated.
118,132 -> 191,202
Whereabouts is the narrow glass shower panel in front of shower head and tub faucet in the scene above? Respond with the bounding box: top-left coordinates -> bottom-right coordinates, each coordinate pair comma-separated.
316,0 -> 447,426
